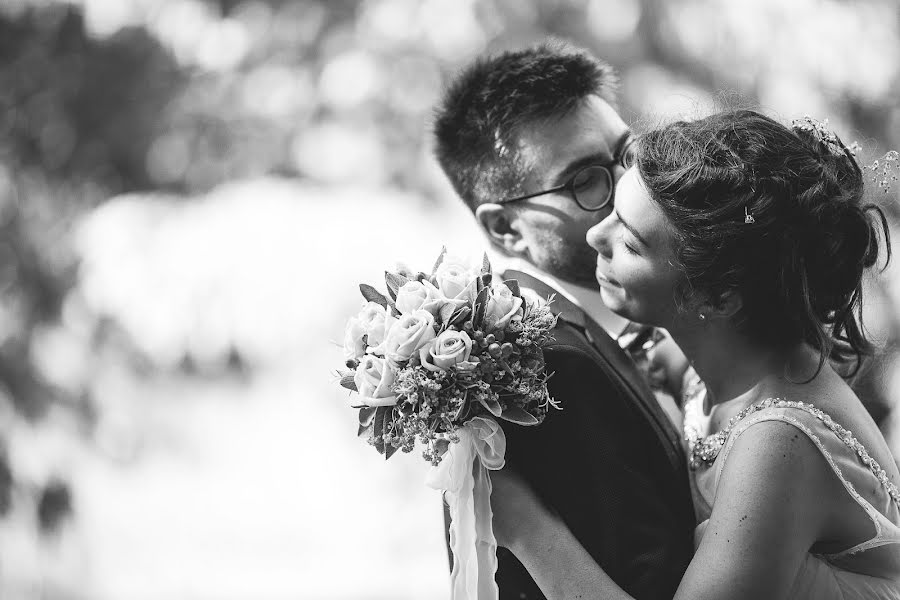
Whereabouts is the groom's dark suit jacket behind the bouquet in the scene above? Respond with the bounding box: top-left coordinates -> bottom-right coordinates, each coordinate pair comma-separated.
451,271 -> 695,600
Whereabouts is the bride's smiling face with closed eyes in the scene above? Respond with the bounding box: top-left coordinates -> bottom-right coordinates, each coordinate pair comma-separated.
587,168 -> 683,327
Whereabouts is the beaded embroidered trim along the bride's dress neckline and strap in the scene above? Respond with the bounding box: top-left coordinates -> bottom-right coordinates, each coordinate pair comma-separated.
684,398 -> 900,508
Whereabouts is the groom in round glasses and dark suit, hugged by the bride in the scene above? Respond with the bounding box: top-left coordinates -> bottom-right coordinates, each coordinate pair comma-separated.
435,43 -> 694,600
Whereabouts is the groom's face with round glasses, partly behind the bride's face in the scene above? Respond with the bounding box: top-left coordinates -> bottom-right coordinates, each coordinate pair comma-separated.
515,95 -> 629,287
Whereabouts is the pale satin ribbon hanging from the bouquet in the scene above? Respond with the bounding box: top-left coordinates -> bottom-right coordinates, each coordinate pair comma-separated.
426,417 -> 506,600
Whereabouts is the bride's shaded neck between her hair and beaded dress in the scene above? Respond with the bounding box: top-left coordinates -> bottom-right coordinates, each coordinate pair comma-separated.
670,324 -> 784,405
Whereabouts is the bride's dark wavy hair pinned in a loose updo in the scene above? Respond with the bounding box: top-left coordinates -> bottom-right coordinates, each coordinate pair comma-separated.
637,110 -> 890,372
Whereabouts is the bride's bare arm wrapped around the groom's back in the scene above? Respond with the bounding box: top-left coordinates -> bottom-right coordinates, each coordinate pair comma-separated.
492,422 -> 840,600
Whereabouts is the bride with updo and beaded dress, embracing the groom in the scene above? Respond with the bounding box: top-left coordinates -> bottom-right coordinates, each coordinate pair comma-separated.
491,110 -> 900,600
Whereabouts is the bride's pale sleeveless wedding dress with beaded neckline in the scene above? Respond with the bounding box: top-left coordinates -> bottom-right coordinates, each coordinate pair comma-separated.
684,376 -> 900,600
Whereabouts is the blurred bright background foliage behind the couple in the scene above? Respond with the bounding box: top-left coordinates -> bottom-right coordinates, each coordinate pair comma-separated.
0,0 -> 900,600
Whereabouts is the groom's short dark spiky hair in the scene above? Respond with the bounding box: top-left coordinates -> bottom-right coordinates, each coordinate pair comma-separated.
434,40 -> 617,210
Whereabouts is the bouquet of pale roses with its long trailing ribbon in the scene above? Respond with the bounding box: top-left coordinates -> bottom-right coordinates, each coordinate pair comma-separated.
340,249 -> 558,599
